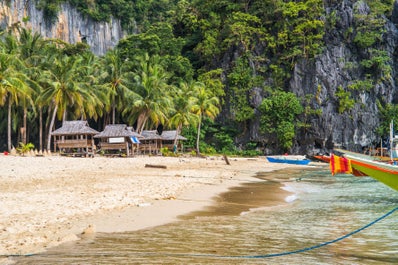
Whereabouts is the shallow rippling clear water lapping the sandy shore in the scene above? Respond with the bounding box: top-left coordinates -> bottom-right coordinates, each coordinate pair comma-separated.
16,168 -> 398,264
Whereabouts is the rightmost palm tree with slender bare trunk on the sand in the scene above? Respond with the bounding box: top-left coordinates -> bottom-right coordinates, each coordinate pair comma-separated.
193,82 -> 220,155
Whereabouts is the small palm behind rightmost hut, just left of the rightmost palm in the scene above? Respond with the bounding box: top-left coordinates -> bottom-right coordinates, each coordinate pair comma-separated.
169,82 -> 199,146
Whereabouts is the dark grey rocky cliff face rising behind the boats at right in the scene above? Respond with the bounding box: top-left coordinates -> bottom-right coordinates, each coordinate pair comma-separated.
290,0 -> 398,153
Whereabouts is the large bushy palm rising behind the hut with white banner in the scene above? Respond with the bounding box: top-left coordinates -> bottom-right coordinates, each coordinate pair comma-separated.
123,54 -> 172,133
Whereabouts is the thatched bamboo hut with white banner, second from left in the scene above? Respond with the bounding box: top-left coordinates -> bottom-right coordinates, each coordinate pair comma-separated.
94,124 -> 142,156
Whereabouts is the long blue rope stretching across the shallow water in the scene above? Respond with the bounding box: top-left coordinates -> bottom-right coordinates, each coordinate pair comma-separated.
0,207 -> 398,259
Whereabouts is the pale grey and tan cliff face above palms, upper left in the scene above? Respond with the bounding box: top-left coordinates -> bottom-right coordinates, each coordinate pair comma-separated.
0,0 -> 123,55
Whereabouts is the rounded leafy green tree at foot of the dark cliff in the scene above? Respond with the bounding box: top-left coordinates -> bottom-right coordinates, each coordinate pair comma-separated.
259,91 -> 303,151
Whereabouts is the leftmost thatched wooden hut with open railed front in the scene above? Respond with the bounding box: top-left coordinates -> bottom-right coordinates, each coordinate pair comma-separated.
51,121 -> 98,156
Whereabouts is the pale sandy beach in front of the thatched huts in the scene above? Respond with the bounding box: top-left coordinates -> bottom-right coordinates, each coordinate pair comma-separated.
0,155 -> 308,264
